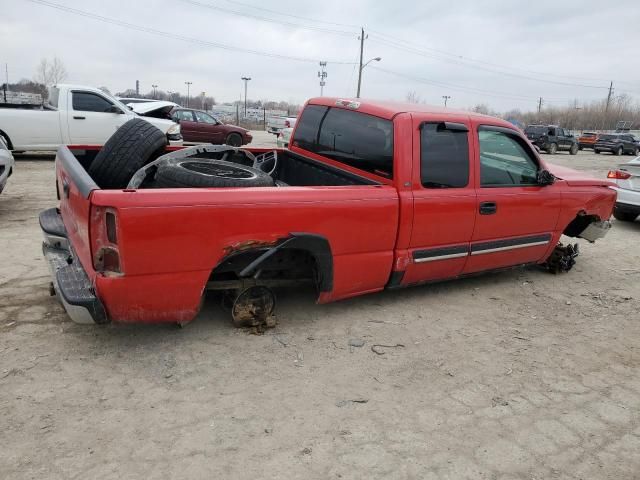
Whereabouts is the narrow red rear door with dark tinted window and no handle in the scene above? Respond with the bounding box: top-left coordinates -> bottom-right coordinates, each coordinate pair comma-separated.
402,114 -> 477,285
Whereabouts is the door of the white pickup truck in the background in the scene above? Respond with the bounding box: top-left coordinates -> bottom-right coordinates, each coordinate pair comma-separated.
67,90 -> 131,145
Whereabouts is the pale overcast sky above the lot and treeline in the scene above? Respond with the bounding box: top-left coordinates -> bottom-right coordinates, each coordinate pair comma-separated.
0,0 -> 640,111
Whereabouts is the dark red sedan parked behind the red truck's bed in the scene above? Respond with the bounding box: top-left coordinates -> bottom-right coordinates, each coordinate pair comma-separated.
168,107 -> 253,147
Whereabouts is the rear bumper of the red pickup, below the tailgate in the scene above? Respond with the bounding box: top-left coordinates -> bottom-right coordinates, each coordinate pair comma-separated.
40,208 -> 109,324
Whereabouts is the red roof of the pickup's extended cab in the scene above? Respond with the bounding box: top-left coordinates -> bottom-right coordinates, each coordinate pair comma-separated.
307,97 -> 513,128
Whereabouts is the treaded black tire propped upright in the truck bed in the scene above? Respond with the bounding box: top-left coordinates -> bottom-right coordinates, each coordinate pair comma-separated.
89,118 -> 167,189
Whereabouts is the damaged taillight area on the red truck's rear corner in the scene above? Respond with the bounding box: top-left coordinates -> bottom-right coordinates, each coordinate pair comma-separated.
91,206 -> 123,274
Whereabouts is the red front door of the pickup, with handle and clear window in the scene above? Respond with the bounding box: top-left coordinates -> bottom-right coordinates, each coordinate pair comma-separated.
464,124 -> 562,273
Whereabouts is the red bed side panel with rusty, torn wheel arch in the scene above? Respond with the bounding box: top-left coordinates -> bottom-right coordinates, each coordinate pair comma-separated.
92,186 -> 398,322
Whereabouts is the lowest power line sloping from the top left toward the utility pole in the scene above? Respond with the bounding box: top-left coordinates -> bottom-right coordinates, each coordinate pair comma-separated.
27,0 -> 352,65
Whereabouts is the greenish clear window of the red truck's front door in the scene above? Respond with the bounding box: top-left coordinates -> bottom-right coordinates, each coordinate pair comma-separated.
478,127 -> 538,187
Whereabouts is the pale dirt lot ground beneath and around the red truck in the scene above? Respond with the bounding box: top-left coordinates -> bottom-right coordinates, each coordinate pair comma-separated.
0,147 -> 640,480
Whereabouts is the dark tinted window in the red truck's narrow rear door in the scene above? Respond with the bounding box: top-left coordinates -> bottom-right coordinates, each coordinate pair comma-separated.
420,122 -> 469,188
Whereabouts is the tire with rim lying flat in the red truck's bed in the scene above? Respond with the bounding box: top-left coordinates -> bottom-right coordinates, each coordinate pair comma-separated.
154,158 -> 274,188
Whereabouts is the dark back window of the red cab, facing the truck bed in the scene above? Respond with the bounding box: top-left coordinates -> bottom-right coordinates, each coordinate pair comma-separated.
295,105 -> 393,178
